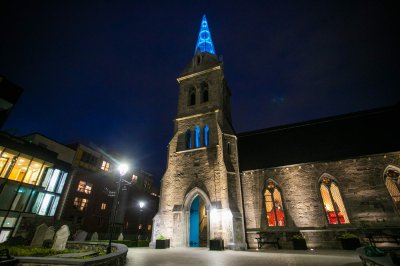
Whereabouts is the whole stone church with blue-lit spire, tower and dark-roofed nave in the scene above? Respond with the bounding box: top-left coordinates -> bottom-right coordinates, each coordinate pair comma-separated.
150,16 -> 400,250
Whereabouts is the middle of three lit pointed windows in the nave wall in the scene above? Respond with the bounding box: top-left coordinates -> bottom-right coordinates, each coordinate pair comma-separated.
320,176 -> 349,224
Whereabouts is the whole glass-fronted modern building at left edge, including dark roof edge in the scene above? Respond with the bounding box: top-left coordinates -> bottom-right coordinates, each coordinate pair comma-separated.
0,133 -> 70,243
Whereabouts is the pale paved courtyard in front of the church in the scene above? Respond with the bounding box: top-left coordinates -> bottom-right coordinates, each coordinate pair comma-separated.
126,248 -> 362,266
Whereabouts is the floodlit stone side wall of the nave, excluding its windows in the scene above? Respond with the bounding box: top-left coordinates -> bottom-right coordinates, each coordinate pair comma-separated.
242,152 -> 400,248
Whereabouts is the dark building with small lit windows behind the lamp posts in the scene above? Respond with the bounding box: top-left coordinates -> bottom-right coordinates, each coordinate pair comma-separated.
25,133 -> 158,239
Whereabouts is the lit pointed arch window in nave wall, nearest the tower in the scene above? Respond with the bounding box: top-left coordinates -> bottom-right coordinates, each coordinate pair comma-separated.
264,180 -> 285,226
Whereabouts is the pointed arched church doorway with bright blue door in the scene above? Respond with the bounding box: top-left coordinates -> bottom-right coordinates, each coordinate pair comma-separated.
189,195 -> 208,247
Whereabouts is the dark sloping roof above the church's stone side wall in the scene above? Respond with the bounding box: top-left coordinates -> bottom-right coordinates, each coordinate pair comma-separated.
237,104 -> 400,171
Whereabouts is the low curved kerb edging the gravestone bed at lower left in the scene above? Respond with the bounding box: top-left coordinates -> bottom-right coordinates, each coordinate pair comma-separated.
15,241 -> 128,266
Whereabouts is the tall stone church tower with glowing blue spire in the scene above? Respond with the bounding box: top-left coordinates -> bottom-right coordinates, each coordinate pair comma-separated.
151,16 -> 246,250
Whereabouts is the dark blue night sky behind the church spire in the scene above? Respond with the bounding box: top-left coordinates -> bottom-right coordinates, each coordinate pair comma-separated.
0,1 -> 400,187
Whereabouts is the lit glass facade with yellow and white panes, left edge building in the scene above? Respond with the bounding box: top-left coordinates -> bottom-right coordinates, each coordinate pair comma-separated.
0,146 -> 68,243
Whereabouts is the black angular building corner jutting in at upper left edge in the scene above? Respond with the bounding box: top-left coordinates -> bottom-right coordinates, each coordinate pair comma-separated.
0,76 -> 23,128
